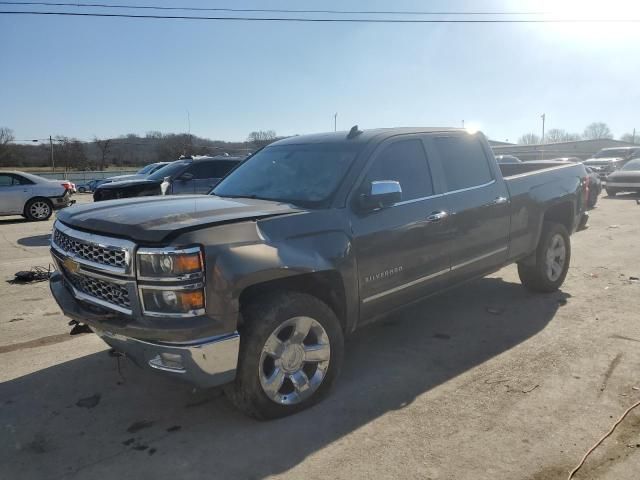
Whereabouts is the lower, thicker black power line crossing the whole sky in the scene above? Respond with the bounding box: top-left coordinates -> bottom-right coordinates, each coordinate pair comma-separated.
0,11 -> 640,24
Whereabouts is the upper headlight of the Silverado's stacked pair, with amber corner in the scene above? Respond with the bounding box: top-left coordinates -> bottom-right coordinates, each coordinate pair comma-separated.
138,247 -> 204,280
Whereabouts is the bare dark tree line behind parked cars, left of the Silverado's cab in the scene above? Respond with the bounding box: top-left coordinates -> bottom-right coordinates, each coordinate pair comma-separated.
0,127 -> 279,170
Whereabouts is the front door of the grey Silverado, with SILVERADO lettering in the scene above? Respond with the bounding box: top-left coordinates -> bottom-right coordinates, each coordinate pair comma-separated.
350,135 -> 449,319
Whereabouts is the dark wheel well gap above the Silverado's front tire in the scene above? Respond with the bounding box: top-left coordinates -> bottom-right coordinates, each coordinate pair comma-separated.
239,271 -> 347,330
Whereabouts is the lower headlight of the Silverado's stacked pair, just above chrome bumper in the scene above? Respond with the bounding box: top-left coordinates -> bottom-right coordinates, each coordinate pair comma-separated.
140,287 -> 204,315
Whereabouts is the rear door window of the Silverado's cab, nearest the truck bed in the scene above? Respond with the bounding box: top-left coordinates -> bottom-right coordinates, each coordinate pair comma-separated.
434,136 -> 493,192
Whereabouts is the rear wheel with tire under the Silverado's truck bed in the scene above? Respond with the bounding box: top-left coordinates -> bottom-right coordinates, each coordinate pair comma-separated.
518,222 -> 571,293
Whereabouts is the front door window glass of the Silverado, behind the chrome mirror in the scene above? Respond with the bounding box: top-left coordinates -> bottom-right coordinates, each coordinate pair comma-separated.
365,139 -> 433,201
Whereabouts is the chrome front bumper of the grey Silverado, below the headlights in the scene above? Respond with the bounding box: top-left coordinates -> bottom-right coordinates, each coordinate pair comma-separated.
94,328 -> 240,388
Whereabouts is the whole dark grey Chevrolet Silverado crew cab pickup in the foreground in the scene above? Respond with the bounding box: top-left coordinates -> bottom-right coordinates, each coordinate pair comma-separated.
50,127 -> 588,419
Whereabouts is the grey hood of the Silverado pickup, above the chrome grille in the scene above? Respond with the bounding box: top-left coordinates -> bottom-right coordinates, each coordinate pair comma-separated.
58,195 -> 303,244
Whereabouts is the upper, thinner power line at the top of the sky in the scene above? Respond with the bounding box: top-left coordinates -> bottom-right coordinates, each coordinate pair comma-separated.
0,1 -> 548,15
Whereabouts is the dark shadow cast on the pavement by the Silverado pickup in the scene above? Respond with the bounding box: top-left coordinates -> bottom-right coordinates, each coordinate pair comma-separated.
0,278 -> 568,479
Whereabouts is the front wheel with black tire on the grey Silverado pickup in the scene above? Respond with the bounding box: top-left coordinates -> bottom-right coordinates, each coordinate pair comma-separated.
226,292 -> 344,420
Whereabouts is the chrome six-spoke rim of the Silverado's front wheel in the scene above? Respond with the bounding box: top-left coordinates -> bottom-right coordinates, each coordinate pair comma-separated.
258,317 -> 331,405
